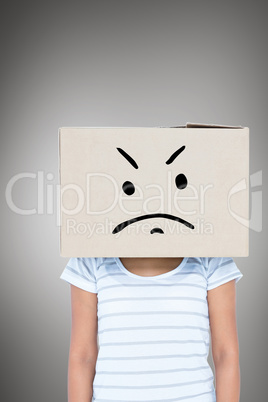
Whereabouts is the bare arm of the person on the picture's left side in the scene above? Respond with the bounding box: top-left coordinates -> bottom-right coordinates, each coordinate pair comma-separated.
68,285 -> 98,402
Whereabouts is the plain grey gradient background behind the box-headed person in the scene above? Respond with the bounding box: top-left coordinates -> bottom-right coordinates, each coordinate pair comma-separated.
0,1 -> 268,402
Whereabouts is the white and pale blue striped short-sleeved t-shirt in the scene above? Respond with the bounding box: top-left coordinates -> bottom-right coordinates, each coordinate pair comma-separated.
60,257 -> 243,402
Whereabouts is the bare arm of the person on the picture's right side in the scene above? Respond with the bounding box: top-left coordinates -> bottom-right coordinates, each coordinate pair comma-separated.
207,279 -> 240,402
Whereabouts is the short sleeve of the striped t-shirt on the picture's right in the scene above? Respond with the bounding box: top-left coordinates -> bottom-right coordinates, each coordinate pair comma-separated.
207,257 -> 243,290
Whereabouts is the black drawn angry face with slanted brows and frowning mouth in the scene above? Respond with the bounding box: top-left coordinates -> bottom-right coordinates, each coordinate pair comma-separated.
112,145 -> 194,234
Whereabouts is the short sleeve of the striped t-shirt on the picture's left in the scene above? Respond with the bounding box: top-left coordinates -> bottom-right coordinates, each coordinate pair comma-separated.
60,257 -> 97,293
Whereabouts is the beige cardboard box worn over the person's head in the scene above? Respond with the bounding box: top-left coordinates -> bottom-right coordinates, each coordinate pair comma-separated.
59,123 -> 249,257
